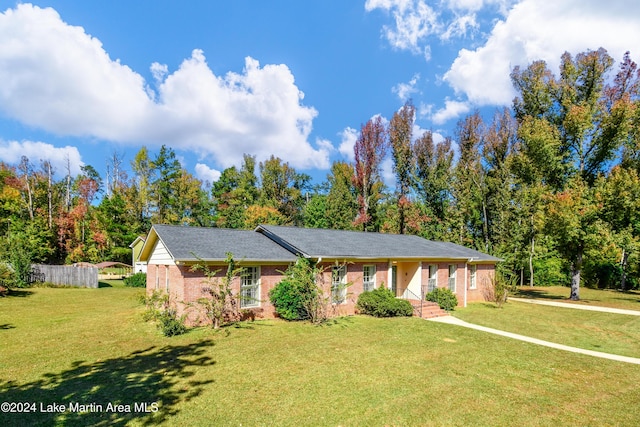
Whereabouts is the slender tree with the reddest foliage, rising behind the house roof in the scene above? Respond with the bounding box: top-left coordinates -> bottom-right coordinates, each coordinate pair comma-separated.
353,116 -> 387,231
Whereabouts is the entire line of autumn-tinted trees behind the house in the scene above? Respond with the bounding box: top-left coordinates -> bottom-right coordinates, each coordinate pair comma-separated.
0,49 -> 640,298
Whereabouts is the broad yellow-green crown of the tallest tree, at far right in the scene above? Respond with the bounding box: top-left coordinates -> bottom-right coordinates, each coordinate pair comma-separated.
511,49 -> 633,189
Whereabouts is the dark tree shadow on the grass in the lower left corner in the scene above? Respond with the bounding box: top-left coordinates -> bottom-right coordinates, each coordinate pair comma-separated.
0,341 -> 215,426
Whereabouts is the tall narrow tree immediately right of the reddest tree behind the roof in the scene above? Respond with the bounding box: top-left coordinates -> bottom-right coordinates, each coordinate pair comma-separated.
389,100 -> 416,234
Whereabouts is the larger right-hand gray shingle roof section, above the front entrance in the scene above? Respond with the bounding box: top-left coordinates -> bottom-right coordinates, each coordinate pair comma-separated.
256,225 -> 500,262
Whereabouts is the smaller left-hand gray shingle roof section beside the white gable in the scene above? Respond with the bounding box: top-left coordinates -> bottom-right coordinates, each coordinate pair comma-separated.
153,224 -> 296,263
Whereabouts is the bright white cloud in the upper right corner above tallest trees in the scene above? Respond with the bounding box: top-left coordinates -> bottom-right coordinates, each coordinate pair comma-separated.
444,0 -> 640,105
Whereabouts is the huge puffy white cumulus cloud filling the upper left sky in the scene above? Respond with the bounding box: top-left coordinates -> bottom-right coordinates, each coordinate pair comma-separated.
0,4 -> 329,169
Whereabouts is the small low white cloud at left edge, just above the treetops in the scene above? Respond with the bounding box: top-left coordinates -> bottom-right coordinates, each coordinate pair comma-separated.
0,140 -> 84,177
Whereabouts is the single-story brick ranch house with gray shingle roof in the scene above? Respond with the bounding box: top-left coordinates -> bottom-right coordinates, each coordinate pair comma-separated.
139,225 -> 500,324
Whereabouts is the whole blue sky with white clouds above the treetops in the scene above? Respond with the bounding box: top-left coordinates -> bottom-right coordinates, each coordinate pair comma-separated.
0,0 -> 640,189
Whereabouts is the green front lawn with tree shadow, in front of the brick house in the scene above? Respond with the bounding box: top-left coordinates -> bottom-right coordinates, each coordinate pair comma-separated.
0,287 -> 640,426
